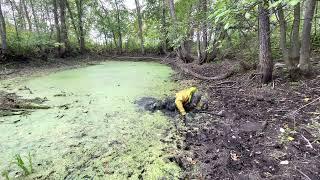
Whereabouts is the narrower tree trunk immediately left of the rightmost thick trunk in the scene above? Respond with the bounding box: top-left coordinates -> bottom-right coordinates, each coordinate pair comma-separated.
290,3 -> 300,66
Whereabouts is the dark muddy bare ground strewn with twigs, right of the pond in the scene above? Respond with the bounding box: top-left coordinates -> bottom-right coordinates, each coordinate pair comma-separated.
172,62 -> 320,180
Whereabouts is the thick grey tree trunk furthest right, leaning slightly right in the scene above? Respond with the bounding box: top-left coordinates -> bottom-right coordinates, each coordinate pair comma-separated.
299,0 -> 316,75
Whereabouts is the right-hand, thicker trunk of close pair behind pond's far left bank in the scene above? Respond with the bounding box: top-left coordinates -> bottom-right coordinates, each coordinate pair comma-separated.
59,0 -> 69,57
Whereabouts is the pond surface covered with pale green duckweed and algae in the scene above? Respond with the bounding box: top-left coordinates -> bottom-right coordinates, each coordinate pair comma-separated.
0,62 -> 179,179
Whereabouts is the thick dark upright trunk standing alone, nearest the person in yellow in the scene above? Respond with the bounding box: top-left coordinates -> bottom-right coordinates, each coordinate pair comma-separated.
259,0 -> 273,84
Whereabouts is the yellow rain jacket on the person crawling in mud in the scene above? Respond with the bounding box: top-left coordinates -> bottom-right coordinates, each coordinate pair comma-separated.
175,87 -> 197,115
